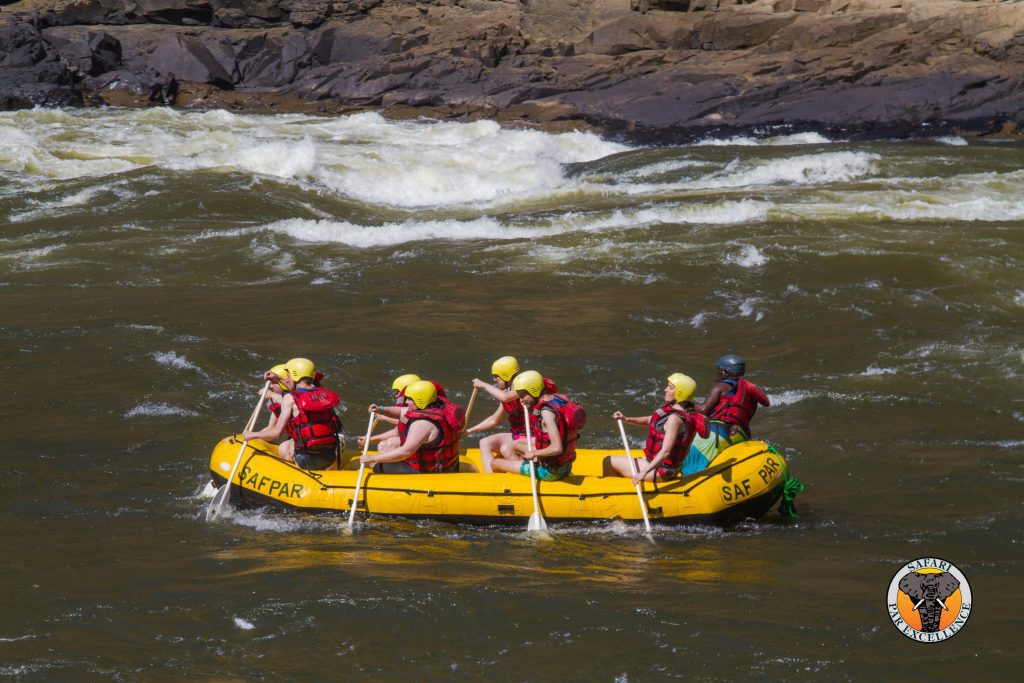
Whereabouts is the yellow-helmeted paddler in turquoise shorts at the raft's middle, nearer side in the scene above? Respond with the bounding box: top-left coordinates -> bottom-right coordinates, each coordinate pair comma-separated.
484,370 -> 587,481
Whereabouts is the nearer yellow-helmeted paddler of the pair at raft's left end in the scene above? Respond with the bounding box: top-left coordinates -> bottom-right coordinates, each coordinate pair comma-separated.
243,358 -> 341,470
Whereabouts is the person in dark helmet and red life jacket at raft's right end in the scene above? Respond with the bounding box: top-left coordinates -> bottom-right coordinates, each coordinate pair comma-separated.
694,353 -> 770,457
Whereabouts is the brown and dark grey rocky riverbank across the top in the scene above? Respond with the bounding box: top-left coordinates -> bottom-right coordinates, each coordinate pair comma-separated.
0,0 -> 1024,141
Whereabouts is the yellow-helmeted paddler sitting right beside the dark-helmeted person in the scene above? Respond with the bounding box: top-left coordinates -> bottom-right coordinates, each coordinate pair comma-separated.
603,373 -> 709,484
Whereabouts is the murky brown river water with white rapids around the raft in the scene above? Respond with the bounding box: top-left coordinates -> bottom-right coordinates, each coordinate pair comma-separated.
0,109 -> 1024,681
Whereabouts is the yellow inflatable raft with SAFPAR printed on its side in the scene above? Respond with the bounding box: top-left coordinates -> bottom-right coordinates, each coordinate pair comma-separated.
210,436 -> 787,526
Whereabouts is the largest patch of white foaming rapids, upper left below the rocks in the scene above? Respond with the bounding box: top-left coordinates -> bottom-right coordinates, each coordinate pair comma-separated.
0,111 -> 629,208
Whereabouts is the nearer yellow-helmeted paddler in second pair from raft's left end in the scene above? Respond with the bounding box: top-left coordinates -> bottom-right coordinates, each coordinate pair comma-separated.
359,381 -> 466,474
